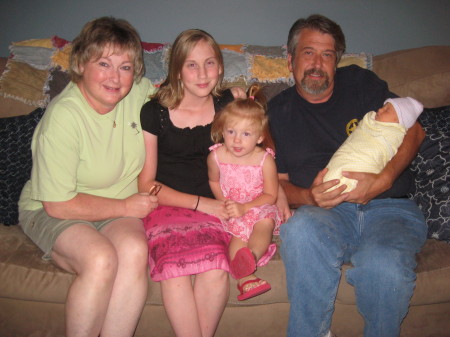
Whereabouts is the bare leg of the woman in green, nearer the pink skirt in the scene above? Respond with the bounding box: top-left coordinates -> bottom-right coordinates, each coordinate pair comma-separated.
100,218 -> 148,337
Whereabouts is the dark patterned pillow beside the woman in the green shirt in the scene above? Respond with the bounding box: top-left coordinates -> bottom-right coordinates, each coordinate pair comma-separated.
0,108 -> 44,225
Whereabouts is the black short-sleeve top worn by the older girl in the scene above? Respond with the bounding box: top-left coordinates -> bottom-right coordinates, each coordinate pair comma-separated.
141,90 -> 233,198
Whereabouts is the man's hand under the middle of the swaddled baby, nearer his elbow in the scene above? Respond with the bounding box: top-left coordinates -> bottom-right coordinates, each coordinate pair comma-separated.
342,171 -> 392,204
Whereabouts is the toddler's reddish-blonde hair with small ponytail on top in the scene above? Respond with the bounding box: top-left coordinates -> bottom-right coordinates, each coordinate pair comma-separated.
211,84 -> 275,150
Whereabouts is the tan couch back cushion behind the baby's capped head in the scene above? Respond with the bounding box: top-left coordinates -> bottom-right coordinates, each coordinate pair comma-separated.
373,46 -> 450,108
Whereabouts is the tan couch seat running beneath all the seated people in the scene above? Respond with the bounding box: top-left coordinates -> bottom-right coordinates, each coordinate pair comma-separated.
0,225 -> 450,306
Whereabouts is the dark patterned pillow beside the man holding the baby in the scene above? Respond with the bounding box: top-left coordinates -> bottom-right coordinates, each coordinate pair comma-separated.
410,106 -> 450,243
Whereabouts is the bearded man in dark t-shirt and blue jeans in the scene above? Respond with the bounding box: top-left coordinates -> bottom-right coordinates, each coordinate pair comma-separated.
269,15 -> 426,337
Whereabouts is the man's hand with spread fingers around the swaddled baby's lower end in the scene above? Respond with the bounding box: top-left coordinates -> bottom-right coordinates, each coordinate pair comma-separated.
309,168 -> 349,208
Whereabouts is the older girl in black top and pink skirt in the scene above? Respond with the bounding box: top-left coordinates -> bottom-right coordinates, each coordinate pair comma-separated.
139,29 -> 245,337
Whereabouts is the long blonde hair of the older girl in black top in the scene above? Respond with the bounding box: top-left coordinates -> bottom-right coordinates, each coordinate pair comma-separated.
154,29 -> 224,109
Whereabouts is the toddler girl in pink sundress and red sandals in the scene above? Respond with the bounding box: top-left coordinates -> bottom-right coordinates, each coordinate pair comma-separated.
208,85 -> 282,301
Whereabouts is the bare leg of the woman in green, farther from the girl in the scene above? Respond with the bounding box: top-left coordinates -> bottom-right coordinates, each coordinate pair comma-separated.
52,224 -> 117,337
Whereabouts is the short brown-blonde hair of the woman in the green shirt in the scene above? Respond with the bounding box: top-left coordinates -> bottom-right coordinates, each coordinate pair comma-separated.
70,17 -> 145,83
